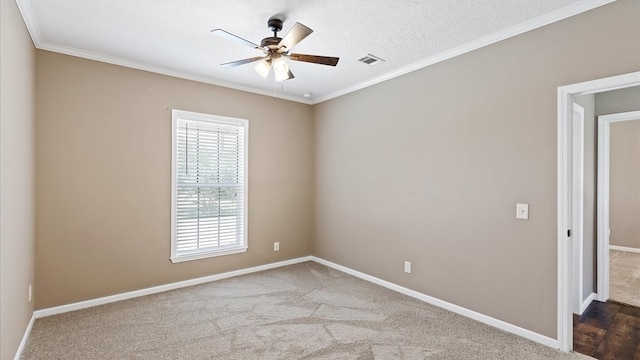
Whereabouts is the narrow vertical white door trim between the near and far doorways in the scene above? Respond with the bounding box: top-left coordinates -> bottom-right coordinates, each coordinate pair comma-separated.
571,102 -> 584,314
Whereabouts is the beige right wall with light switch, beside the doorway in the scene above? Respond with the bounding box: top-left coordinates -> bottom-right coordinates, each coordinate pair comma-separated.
314,0 -> 640,337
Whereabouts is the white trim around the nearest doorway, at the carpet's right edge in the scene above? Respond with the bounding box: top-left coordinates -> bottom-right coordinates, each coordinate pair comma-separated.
557,71 -> 640,351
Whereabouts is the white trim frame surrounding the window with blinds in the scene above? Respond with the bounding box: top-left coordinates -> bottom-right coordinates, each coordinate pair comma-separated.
170,109 -> 249,263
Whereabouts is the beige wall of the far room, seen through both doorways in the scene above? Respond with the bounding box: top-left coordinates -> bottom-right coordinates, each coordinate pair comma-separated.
609,119 -> 640,249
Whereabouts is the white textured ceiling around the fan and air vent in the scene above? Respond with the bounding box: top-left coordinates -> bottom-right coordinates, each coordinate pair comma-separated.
16,0 -> 613,104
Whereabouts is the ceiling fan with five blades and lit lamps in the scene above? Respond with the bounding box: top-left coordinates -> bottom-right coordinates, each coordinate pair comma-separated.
211,16 -> 340,81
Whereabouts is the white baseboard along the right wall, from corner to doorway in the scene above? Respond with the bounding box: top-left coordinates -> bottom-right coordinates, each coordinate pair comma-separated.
312,256 -> 560,349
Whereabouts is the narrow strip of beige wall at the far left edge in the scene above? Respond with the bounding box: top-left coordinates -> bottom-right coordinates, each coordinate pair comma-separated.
0,0 -> 37,359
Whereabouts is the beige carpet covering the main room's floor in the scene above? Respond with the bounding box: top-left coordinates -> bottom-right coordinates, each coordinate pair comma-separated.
22,262 -> 590,360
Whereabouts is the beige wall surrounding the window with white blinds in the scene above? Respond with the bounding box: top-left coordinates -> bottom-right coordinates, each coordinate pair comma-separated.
36,51 -> 314,309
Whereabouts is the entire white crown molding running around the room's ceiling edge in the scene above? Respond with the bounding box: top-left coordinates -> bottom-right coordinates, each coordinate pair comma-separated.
16,0 -> 615,105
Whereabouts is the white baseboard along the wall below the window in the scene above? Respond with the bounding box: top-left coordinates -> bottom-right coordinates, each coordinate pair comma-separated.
33,256 -> 312,319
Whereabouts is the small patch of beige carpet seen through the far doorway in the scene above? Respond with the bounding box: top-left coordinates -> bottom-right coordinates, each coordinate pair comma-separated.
609,250 -> 640,307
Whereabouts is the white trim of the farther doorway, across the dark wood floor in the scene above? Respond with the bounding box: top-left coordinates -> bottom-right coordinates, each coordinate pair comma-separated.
597,111 -> 640,301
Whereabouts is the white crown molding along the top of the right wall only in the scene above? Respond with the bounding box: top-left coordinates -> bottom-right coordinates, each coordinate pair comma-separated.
313,0 -> 616,105
